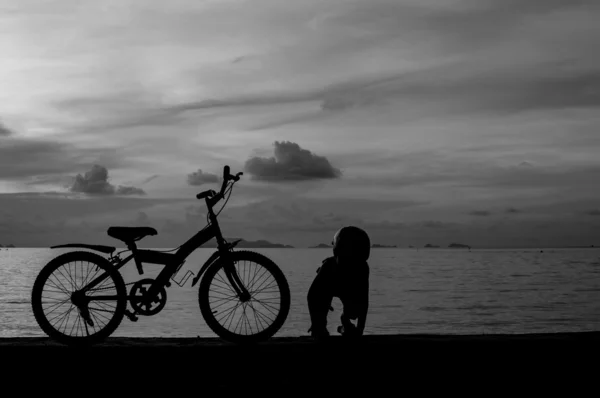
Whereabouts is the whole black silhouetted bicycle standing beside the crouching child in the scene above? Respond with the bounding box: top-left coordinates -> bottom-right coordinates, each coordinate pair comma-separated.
31,166 -> 290,345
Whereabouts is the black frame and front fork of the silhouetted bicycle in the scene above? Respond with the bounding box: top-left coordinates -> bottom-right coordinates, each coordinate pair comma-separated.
80,187 -> 249,308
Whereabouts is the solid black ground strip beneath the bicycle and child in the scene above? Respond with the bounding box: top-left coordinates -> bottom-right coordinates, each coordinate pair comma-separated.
0,332 -> 600,396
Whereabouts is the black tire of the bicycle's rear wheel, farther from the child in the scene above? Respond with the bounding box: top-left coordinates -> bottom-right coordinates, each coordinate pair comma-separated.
31,251 -> 127,345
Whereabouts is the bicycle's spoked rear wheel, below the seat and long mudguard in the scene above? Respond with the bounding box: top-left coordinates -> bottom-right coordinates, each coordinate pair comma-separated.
31,251 -> 127,345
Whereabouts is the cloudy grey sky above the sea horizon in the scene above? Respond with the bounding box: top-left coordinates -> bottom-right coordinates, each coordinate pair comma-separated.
0,0 -> 600,247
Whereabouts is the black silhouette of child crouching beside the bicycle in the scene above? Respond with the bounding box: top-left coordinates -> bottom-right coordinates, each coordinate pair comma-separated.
307,226 -> 371,338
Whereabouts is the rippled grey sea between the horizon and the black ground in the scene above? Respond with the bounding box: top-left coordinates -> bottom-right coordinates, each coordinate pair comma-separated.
0,248 -> 600,338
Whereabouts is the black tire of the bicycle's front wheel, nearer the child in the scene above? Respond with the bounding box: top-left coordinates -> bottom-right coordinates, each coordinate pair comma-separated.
198,250 -> 290,344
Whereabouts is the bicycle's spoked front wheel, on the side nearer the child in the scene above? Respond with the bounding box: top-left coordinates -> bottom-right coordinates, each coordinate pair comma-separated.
198,251 -> 290,344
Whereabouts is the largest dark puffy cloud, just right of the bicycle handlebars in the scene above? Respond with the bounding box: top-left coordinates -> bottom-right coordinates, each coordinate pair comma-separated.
245,141 -> 342,181
